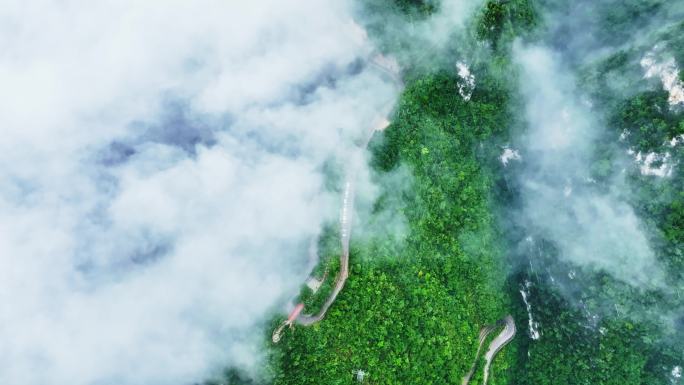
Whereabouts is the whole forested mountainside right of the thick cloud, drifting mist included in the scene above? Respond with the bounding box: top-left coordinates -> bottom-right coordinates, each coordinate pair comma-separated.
229,0 -> 684,384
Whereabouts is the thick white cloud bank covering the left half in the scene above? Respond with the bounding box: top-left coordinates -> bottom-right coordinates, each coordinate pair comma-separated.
0,0 -> 397,385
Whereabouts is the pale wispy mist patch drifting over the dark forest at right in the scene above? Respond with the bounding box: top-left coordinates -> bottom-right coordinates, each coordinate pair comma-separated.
514,45 -> 663,288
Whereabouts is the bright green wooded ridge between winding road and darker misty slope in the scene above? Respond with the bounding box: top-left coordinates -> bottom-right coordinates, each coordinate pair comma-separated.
272,61 -> 513,384
